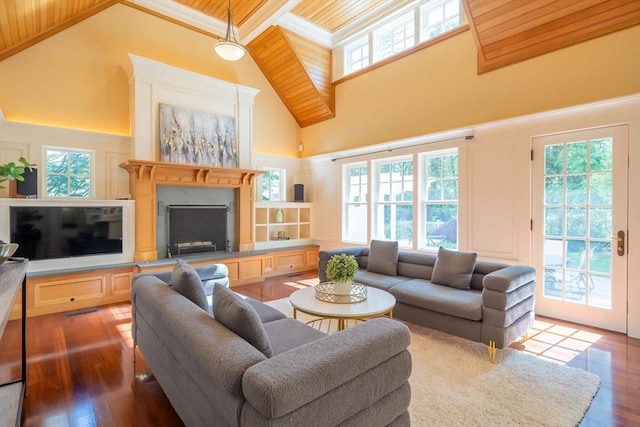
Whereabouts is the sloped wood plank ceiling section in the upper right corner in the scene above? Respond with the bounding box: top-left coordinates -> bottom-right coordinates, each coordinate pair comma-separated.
463,0 -> 640,72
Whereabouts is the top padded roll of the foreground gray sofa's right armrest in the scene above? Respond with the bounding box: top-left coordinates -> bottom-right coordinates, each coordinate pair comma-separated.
242,318 -> 411,425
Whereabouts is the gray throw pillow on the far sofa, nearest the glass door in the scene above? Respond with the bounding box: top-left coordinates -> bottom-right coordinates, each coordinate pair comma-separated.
431,247 -> 478,289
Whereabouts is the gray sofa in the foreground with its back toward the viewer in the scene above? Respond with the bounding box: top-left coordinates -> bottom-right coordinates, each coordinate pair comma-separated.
131,264 -> 411,427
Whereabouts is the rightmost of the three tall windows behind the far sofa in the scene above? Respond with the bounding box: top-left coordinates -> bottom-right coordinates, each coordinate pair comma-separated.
422,152 -> 458,249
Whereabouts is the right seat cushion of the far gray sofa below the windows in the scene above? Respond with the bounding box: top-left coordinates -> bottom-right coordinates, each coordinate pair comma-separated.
389,279 -> 482,321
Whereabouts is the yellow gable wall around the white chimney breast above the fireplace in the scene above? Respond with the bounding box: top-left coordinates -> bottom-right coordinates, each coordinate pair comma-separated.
0,4 -> 300,157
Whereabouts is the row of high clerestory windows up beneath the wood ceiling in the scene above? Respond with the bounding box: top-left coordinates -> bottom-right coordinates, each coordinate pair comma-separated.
336,0 -> 466,77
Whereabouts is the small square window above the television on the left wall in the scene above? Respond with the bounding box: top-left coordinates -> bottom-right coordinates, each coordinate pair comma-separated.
44,147 -> 93,198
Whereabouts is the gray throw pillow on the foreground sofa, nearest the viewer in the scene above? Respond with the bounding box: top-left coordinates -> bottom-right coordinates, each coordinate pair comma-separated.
213,284 -> 273,357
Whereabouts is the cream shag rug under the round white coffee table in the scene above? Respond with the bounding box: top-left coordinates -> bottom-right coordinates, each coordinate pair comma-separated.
267,298 -> 600,426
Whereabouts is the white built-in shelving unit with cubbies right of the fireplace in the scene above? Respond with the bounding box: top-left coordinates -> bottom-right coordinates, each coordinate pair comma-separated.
254,202 -> 311,249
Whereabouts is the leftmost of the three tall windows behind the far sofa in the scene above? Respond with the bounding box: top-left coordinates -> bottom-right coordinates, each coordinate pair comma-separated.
343,163 -> 369,244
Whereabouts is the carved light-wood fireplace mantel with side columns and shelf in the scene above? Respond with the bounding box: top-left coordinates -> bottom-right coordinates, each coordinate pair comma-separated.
120,160 -> 264,261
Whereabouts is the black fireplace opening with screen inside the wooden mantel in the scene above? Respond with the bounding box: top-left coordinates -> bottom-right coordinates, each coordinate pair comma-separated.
167,205 -> 229,258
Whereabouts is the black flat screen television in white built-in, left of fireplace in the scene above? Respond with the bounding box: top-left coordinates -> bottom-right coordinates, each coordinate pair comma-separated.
9,206 -> 123,261
